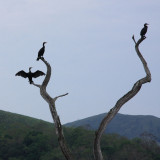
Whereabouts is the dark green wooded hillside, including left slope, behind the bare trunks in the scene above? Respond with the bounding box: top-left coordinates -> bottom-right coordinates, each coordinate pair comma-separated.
0,111 -> 160,160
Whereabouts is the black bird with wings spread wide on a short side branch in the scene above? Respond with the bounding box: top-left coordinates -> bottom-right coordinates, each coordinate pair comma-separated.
15,67 -> 45,84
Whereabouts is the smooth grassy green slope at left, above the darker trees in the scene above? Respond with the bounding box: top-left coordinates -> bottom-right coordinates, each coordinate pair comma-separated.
0,110 -> 53,135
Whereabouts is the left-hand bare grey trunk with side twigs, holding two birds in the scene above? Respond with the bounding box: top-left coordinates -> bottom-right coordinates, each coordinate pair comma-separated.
32,58 -> 72,160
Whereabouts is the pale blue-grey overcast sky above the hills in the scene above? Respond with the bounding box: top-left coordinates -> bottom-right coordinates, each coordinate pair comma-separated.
0,0 -> 160,123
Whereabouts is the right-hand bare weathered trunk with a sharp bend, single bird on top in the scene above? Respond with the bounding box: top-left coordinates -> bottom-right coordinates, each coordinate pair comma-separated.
94,36 -> 151,160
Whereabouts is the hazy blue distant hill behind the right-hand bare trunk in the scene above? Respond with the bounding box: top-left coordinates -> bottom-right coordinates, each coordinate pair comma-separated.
65,113 -> 160,142
